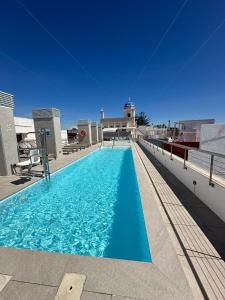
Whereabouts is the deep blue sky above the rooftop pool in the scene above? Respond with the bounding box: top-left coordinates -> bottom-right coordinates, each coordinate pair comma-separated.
0,0 -> 225,128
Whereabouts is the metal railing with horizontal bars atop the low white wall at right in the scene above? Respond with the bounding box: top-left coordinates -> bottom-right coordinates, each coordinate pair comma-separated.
139,138 -> 225,187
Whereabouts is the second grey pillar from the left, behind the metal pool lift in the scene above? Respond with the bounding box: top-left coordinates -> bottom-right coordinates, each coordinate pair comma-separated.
32,108 -> 62,158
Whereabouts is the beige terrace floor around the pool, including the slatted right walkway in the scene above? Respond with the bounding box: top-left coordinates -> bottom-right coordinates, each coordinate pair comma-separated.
0,144 -> 225,300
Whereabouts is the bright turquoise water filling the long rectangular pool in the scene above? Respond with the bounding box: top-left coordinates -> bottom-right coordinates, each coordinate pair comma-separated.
0,147 -> 151,262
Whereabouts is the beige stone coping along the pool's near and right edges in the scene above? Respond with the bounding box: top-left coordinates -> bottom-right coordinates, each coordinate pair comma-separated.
0,144 -> 193,299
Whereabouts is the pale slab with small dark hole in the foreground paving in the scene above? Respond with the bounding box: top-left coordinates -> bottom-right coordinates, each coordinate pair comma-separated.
55,273 -> 86,300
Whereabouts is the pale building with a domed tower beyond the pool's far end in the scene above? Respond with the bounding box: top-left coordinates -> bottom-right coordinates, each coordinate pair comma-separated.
100,97 -> 137,137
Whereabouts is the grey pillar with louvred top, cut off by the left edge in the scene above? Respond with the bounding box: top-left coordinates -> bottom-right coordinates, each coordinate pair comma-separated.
0,91 -> 18,176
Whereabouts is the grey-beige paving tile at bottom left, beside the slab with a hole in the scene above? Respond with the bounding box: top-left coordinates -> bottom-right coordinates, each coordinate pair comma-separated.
0,281 -> 57,300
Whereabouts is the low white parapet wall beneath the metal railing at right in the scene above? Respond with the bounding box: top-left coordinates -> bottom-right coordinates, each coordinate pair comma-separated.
140,140 -> 225,222
